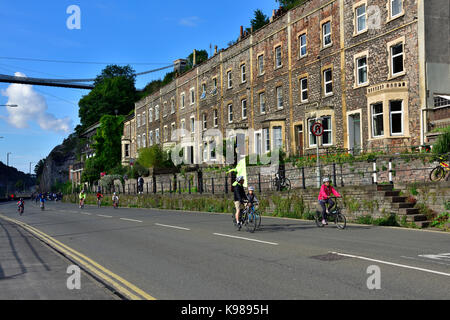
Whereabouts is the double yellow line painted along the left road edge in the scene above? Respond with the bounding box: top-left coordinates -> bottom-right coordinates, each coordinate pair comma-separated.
0,214 -> 156,300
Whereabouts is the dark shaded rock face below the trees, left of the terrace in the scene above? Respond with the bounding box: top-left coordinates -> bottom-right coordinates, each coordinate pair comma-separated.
39,137 -> 77,191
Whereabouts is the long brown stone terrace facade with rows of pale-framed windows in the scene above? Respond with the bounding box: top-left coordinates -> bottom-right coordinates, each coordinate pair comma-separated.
121,0 -> 450,163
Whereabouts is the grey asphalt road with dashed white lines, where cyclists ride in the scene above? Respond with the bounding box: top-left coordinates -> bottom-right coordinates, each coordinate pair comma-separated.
0,202 -> 450,300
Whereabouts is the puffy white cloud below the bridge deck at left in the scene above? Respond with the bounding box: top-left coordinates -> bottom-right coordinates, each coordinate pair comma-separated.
2,72 -> 72,133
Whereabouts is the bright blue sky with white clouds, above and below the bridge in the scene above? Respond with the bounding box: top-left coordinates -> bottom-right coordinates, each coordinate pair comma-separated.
0,0 -> 278,173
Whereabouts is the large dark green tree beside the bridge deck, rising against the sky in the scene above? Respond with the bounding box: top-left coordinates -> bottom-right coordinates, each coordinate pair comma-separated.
76,65 -> 139,130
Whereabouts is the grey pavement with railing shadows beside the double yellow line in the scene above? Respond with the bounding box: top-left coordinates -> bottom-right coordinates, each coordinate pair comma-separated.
0,219 -> 117,300
